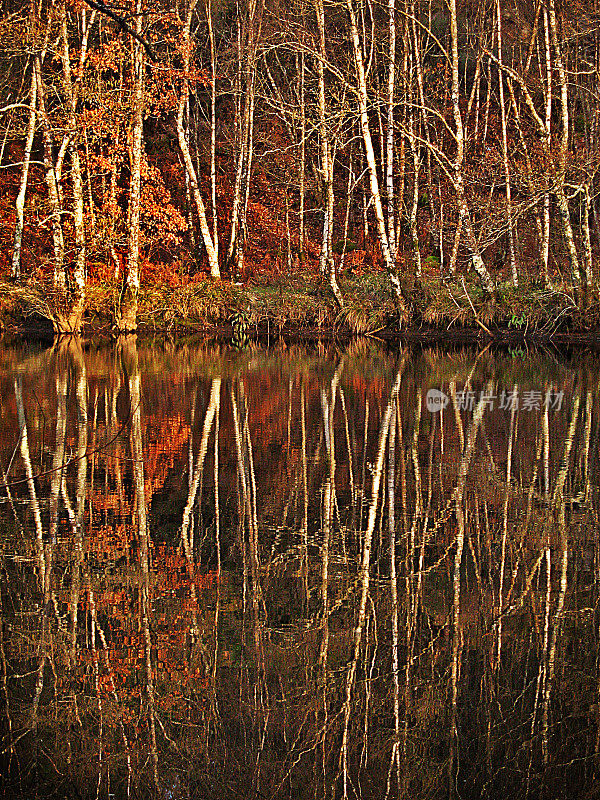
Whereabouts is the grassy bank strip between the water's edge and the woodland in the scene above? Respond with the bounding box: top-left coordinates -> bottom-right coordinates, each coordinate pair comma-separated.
0,270 -> 600,345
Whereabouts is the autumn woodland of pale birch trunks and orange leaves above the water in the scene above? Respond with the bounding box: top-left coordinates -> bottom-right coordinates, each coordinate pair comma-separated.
0,0 -> 600,335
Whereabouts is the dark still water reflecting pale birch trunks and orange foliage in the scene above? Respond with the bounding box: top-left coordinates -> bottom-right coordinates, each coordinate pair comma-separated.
0,342 -> 600,800
